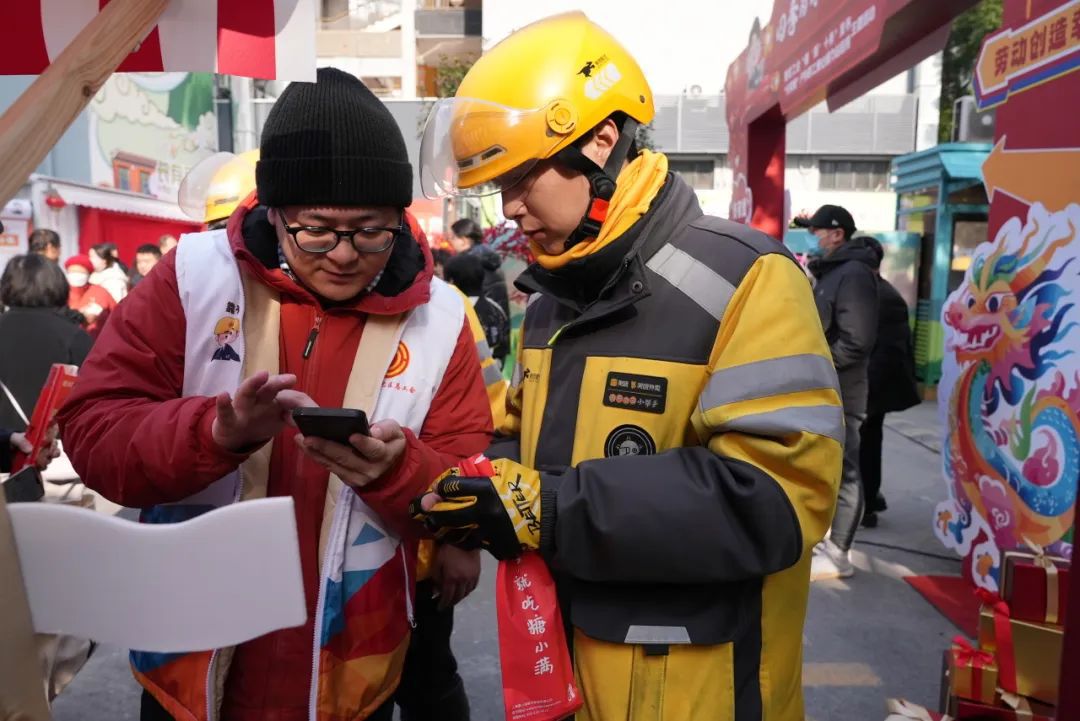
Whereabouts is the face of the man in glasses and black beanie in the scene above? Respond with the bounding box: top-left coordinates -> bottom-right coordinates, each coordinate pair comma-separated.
271,206 -> 402,302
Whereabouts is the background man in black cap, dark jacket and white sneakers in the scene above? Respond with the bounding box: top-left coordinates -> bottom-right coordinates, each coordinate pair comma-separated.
795,205 -> 878,581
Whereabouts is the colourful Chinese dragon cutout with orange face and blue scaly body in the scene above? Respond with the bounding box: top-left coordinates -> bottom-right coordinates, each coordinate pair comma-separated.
934,204 -> 1080,589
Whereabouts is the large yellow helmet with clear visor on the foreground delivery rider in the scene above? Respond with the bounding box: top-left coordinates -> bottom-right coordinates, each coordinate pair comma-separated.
420,12 -> 654,200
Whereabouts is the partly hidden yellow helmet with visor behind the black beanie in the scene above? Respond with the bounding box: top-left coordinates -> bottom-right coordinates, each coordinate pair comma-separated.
179,150 -> 259,225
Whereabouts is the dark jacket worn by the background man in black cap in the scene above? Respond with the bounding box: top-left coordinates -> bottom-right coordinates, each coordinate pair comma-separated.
810,237 -> 878,414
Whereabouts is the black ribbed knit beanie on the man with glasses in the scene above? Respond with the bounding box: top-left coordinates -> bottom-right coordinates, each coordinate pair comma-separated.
255,68 -> 413,208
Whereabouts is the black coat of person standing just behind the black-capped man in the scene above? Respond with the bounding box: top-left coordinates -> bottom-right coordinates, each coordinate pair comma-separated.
866,277 -> 921,413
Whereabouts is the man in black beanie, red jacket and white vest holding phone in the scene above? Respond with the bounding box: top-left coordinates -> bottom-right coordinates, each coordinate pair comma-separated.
60,68 -> 492,721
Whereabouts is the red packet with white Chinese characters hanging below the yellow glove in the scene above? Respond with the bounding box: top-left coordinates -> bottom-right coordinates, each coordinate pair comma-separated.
495,552 -> 581,721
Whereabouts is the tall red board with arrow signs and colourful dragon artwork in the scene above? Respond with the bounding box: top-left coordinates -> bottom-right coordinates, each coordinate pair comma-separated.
933,0 -> 1080,590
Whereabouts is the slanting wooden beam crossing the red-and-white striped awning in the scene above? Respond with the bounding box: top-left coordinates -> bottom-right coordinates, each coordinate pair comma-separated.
0,0 -> 168,207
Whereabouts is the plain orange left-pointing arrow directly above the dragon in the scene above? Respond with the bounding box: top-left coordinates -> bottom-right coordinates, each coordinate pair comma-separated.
983,136 -> 1080,213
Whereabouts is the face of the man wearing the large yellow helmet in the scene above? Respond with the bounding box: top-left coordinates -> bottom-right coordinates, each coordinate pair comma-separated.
502,161 -> 589,256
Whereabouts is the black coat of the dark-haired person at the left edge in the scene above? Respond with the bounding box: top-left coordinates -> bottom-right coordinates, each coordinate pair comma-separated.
0,308 -> 93,431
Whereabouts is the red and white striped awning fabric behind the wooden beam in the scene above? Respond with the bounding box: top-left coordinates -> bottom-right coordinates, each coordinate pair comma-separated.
0,0 -> 316,81
